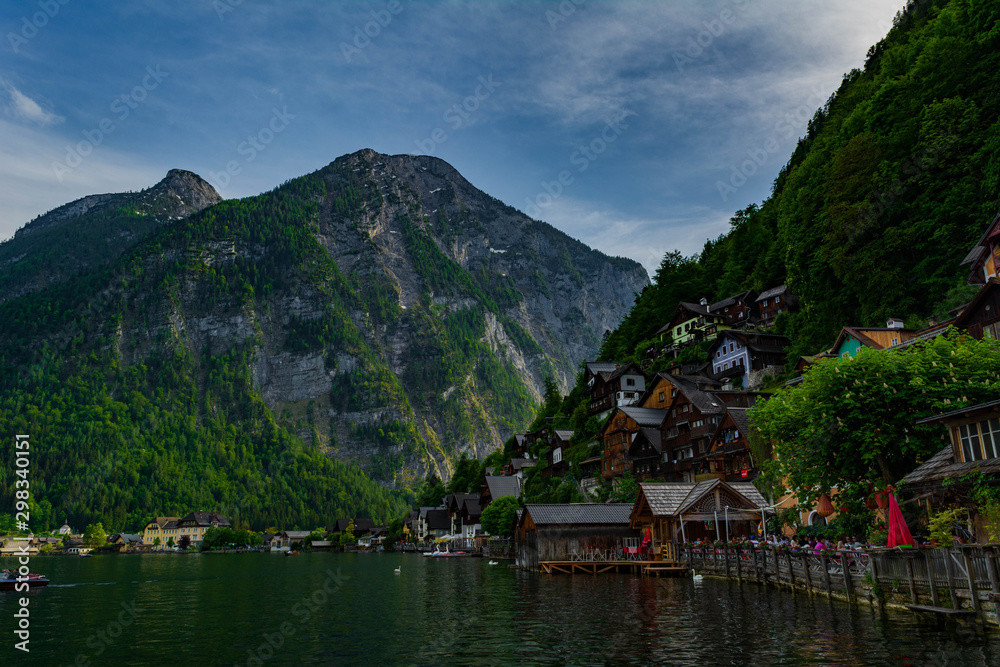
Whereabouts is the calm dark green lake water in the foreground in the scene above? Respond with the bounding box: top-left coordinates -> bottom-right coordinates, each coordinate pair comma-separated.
0,553 -> 1000,667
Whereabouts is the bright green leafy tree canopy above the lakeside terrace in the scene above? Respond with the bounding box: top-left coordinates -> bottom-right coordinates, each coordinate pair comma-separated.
751,330 -> 1000,502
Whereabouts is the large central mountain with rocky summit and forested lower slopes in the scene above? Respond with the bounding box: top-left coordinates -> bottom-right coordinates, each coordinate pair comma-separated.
0,150 -> 648,527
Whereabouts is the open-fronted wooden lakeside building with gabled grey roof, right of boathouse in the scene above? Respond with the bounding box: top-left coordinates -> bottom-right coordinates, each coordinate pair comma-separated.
629,479 -> 771,544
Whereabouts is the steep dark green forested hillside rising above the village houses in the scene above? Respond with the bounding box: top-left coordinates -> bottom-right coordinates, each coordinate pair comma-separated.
602,0 -> 1000,368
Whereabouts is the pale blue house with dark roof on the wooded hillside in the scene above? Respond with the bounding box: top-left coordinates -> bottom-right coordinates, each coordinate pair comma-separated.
708,331 -> 789,389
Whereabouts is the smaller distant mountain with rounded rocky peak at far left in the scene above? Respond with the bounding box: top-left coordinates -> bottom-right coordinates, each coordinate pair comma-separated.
0,169 -> 222,301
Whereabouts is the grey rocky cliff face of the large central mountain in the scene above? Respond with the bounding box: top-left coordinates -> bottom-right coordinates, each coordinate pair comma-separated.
0,150 -> 648,485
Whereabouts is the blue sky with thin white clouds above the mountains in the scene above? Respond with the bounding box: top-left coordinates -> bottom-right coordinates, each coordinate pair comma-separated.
0,0 -> 903,274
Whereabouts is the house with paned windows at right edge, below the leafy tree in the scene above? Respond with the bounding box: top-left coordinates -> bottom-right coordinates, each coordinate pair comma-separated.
901,400 -> 1000,543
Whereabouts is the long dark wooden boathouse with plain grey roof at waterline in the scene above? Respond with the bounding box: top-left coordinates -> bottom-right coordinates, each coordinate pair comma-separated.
514,503 -> 638,570
